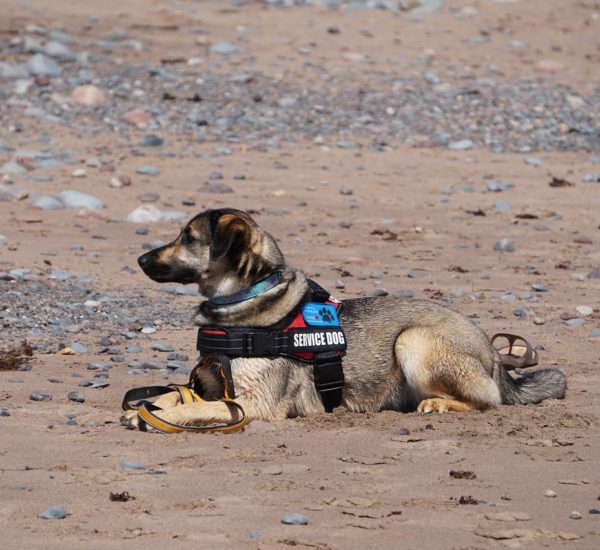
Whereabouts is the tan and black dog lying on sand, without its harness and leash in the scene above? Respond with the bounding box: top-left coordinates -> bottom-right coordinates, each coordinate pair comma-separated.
123,209 -> 566,428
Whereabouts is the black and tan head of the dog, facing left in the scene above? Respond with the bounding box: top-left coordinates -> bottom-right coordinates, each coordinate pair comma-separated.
138,208 -> 285,297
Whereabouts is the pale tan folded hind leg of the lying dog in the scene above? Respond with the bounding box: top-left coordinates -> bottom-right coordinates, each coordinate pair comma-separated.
395,328 -> 500,413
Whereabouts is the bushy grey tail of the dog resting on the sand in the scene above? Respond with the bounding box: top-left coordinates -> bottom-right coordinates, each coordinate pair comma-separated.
493,364 -> 567,405
